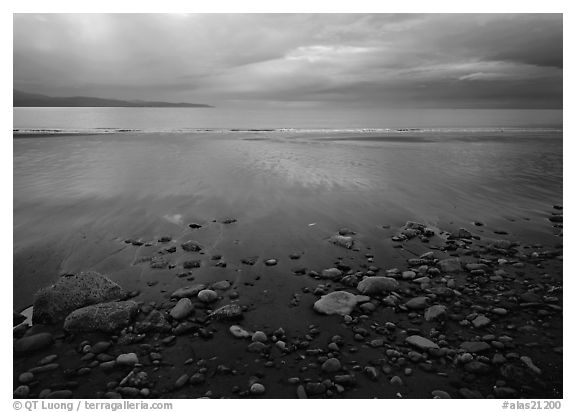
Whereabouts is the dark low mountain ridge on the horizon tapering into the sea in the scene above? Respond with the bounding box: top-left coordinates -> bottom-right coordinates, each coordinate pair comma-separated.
14,90 -> 213,107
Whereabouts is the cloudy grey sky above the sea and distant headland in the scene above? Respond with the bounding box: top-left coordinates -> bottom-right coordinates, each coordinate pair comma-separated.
14,14 -> 562,109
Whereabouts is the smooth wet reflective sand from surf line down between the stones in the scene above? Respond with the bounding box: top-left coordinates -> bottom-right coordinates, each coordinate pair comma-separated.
14,133 -> 562,398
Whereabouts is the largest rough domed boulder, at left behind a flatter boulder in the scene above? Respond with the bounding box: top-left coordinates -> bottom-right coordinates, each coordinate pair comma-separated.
32,272 -> 126,324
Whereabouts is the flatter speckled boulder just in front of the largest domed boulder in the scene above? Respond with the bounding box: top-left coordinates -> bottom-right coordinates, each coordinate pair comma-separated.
64,300 -> 138,332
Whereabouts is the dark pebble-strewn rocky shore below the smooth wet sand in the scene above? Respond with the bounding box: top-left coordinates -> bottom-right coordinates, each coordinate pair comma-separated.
14,214 -> 562,398
